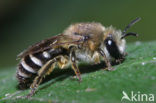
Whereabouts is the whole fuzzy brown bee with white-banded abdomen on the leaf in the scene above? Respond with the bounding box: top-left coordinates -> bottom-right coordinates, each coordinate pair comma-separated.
16,18 -> 141,97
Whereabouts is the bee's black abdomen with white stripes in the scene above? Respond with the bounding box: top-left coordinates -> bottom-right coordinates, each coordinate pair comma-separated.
17,48 -> 66,89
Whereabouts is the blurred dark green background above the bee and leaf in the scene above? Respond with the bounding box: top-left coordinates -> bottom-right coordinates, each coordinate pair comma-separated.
0,0 -> 156,67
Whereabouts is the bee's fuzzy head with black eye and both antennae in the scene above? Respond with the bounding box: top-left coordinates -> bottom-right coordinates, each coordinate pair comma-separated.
104,18 -> 140,59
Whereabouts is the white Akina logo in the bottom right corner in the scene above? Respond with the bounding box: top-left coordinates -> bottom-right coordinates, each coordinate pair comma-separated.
121,91 -> 154,102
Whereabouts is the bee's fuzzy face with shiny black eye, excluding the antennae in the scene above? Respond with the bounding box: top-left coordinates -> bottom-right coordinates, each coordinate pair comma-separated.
104,27 -> 126,59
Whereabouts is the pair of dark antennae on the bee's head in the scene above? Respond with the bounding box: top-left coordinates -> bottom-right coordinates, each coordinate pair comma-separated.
121,17 -> 141,39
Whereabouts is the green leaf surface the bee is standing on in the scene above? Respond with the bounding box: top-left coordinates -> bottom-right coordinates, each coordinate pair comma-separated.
0,41 -> 156,103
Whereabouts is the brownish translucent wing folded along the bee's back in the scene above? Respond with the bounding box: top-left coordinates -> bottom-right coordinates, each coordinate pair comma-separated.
17,34 -> 82,59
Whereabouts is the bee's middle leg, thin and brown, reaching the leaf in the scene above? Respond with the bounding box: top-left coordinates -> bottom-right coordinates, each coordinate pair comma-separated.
70,51 -> 82,82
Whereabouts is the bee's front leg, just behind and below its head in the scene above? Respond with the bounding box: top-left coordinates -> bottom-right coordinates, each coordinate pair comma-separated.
98,48 -> 114,71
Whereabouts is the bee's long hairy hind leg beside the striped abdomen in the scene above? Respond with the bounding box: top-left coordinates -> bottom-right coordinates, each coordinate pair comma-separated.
27,58 -> 57,98
